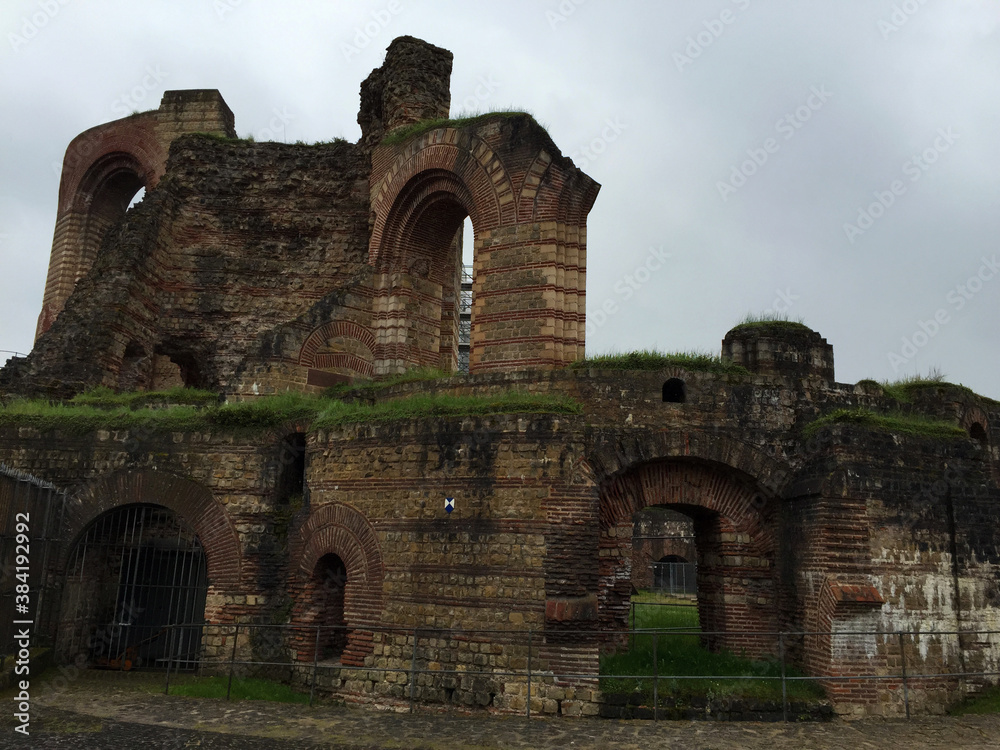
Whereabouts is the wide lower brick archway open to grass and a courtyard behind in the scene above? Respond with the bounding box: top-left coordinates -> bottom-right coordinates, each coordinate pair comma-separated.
599,459 -> 782,655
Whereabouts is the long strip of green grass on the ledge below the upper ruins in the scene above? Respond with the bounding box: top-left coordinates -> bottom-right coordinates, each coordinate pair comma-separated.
0,391 -> 582,434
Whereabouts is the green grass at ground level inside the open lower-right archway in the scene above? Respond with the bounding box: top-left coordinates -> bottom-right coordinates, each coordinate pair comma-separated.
601,601 -> 824,701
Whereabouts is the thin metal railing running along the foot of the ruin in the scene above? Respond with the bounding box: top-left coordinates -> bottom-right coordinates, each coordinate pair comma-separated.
135,623 -> 1000,721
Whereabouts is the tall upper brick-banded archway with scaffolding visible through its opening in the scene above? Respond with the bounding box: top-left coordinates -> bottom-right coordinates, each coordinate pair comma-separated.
369,120 -> 599,373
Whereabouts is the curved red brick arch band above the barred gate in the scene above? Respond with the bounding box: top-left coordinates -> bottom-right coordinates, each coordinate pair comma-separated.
59,471 -> 242,589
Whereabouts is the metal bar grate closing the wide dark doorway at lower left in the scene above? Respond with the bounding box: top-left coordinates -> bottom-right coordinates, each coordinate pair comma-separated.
58,504 -> 207,671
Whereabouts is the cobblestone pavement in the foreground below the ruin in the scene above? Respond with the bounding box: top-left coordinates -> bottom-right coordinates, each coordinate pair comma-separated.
0,680 -> 1000,750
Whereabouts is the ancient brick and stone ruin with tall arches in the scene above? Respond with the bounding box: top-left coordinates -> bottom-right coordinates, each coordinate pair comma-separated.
0,37 -> 1000,715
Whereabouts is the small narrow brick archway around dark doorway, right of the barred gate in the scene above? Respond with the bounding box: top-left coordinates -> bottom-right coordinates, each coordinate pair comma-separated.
289,503 -> 385,666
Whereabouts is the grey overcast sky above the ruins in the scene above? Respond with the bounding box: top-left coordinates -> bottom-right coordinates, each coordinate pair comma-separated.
0,0 -> 1000,398
